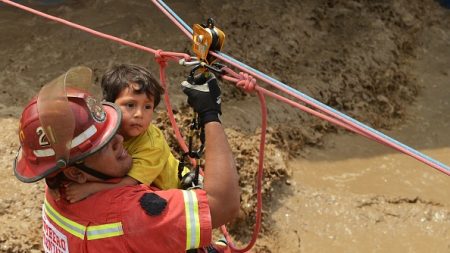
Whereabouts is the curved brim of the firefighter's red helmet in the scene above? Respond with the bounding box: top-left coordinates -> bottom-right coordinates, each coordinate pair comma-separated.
13,102 -> 122,183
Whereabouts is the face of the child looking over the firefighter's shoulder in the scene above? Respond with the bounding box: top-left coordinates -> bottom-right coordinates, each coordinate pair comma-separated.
115,84 -> 154,140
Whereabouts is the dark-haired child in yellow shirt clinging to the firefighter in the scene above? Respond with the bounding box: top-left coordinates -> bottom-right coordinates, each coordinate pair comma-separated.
66,64 -> 186,203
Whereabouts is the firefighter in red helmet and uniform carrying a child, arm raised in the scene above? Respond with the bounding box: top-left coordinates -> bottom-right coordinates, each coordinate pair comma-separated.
14,67 -> 240,252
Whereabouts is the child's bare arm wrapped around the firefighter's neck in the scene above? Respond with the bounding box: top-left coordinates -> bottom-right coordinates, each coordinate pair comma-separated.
65,176 -> 139,203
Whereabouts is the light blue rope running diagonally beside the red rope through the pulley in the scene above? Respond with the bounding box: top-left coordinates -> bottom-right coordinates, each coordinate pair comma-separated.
152,0 -> 450,175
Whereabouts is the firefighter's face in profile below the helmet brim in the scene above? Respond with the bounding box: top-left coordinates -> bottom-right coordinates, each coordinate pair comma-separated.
84,134 -> 132,177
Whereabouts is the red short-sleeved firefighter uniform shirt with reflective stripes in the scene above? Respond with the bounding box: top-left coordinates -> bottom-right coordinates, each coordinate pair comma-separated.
42,185 -> 212,253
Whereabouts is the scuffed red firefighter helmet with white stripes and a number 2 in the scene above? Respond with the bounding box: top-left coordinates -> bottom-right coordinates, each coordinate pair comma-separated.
14,68 -> 122,183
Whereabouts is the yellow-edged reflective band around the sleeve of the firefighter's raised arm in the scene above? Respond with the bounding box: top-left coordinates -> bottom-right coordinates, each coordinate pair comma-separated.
183,191 -> 200,249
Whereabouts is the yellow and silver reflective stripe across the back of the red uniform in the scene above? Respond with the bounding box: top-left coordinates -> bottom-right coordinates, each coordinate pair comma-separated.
42,200 -> 123,240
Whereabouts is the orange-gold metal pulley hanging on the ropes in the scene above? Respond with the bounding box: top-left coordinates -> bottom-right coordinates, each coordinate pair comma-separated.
192,18 -> 225,64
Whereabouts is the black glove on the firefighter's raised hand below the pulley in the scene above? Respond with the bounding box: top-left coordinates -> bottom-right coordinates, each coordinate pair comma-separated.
181,72 -> 222,126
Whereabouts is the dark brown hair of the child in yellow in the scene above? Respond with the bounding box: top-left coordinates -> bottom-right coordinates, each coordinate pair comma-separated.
101,64 -> 164,107
